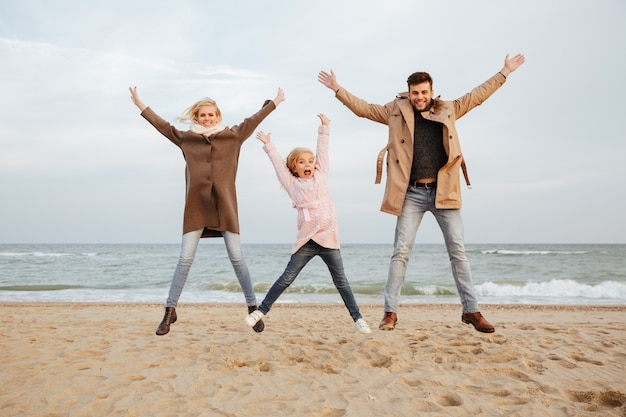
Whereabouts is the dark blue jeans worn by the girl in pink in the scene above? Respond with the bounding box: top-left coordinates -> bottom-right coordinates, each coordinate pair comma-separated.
259,240 -> 361,321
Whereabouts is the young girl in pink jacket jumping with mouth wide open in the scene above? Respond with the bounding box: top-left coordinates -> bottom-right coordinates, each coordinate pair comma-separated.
246,114 -> 372,333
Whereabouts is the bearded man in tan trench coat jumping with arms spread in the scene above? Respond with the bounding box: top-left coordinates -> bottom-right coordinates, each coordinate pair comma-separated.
318,54 -> 524,333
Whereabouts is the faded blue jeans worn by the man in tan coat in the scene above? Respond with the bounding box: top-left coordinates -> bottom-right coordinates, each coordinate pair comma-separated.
385,187 -> 478,313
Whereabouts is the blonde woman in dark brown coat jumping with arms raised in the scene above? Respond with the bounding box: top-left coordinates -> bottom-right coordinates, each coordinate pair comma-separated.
129,87 -> 285,336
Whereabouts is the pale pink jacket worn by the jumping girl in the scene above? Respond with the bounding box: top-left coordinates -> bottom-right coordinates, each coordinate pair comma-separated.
263,126 -> 339,253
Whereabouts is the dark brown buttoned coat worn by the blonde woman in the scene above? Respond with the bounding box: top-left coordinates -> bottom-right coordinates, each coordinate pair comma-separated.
141,100 -> 276,237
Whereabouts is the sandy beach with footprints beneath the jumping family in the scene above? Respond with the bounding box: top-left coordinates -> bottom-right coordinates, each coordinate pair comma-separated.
0,303 -> 626,417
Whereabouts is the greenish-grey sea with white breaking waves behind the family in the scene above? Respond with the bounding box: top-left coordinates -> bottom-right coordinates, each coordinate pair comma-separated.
0,240 -> 626,306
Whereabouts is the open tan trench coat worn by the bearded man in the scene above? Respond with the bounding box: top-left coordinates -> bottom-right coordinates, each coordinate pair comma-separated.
336,73 -> 506,216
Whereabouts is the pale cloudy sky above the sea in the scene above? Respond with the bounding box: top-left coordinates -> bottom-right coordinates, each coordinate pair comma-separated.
0,0 -> 626,244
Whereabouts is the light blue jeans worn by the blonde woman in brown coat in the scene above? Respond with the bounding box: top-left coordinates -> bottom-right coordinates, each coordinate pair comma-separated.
165,229 -> 256,307
